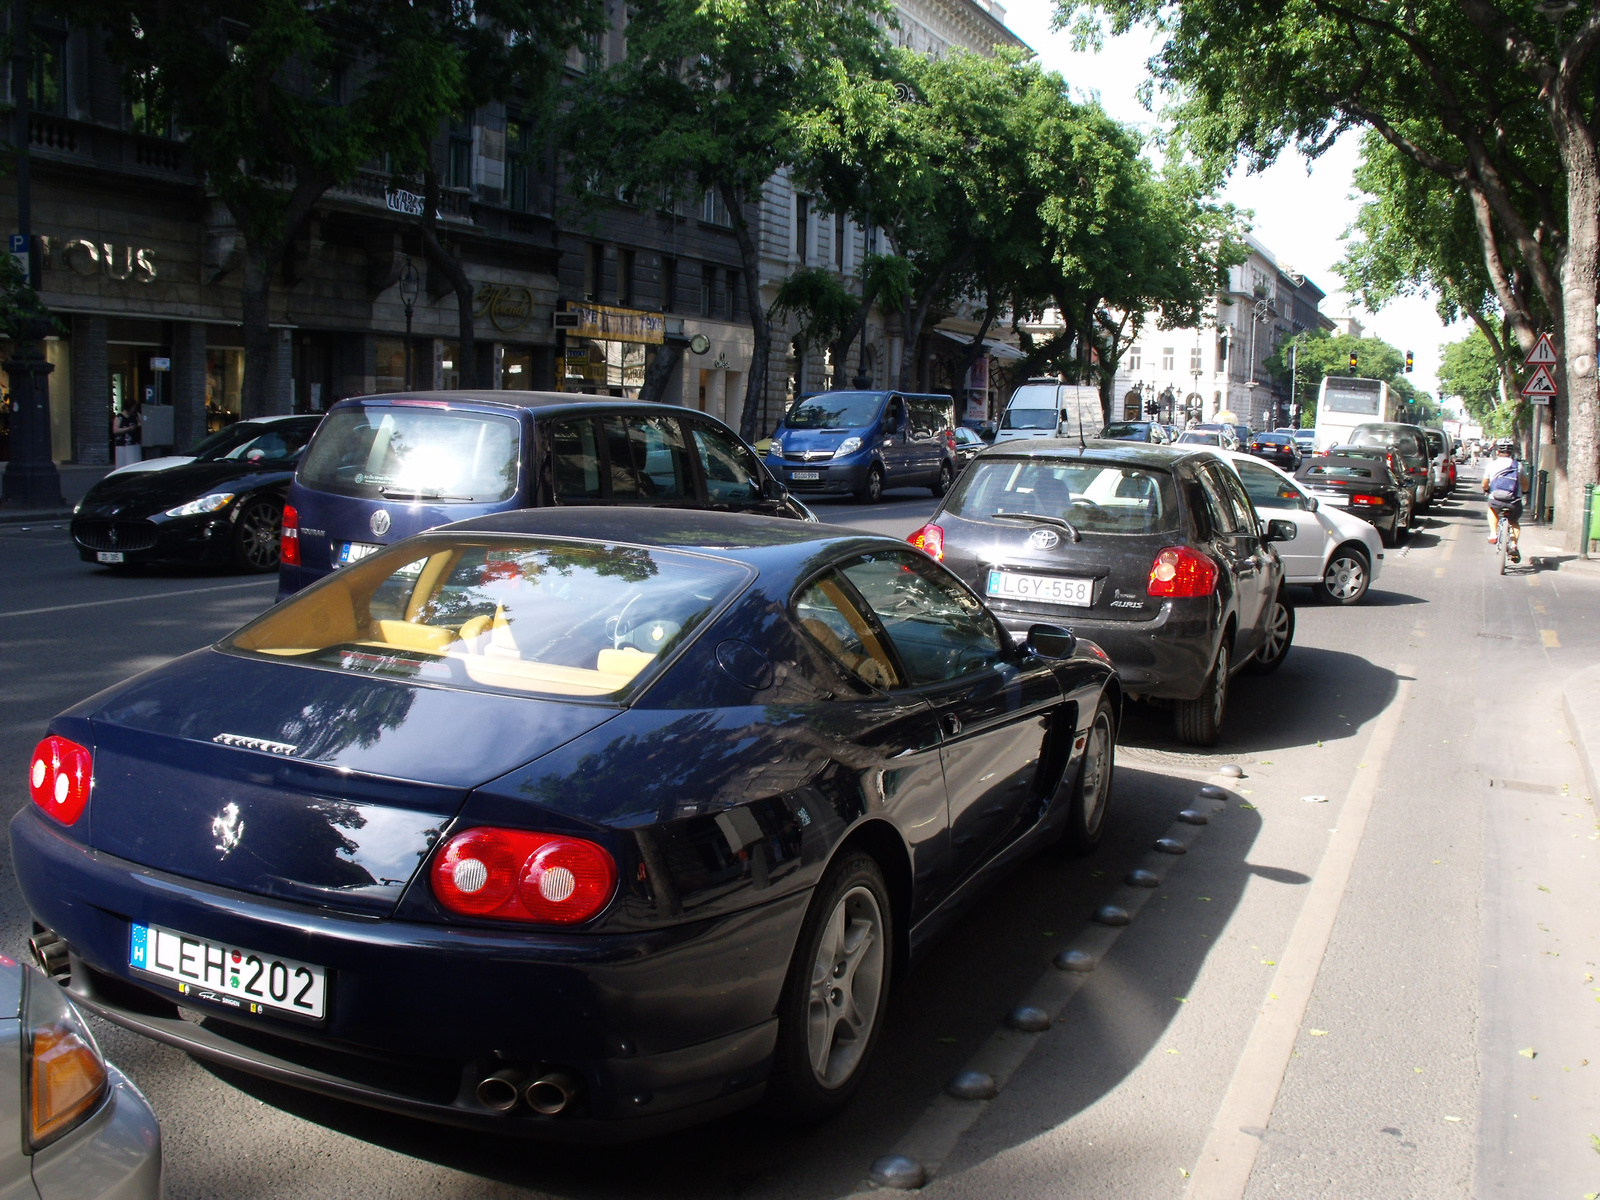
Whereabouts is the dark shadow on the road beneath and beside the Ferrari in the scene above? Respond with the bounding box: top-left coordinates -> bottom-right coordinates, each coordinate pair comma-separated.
193,765 -> 1254,1200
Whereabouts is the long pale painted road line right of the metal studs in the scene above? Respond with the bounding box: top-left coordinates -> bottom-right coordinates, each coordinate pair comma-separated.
1184,666 -> 1414,1200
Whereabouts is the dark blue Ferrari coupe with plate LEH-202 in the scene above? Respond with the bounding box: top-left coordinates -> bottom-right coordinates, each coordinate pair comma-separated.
21,509 -> 1122,1139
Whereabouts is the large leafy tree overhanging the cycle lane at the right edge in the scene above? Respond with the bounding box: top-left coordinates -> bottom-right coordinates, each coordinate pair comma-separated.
1056,0 -> 1600,536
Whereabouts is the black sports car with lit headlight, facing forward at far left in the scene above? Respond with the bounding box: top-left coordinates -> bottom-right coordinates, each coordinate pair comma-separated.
69,416 -> 322,571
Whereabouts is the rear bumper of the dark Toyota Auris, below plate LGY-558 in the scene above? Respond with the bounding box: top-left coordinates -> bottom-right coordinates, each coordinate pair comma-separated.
994,598 -> 1219,699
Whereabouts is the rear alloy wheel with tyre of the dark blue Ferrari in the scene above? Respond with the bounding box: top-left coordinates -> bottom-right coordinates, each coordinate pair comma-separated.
768,851 -> 893,1122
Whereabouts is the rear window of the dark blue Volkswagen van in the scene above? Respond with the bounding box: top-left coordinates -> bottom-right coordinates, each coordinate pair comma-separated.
299,405 -> 522,504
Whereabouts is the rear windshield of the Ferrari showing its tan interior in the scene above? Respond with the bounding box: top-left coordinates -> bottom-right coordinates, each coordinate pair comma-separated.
222,534 -> 750,699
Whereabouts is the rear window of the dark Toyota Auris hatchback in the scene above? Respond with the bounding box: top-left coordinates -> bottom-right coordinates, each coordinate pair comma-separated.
944,458 -> 1178,533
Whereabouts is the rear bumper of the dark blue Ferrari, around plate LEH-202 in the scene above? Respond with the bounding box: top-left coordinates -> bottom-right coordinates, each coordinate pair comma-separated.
11,806 -> 793,1141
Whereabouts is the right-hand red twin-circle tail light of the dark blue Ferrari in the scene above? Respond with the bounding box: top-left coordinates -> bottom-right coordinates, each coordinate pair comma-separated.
432,827 -> 616,925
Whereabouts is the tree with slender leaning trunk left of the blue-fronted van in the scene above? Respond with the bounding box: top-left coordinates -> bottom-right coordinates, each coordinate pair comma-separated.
560,0 -> 888,438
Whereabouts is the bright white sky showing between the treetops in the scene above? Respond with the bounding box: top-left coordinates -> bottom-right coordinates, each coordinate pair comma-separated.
1006,0 -> 1472,395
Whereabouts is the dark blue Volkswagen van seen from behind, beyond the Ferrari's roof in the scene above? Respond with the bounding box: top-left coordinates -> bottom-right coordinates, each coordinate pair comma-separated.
278,392 -> 816,600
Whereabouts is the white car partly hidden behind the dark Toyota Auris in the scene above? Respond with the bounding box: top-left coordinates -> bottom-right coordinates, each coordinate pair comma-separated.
1221,451 -> 1384,605
